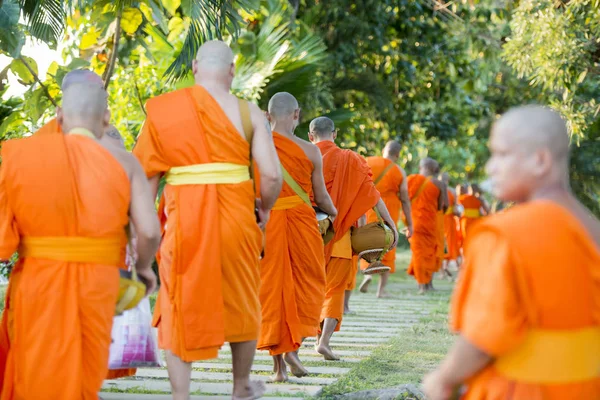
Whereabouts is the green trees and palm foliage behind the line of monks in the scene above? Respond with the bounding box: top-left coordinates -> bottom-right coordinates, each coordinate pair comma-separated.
0,0 -> 600,215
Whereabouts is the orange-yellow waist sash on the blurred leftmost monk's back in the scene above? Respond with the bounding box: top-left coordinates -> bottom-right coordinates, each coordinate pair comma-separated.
19,235 -> 125,266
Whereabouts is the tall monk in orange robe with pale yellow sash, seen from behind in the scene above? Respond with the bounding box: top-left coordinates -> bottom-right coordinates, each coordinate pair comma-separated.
133,40 -> 282,400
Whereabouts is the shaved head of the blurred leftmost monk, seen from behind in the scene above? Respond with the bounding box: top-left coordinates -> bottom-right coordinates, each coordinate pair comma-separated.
58,82 -> 110,138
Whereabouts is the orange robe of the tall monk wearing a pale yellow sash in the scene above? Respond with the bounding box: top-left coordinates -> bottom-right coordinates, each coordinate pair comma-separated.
133,86 -> 262,362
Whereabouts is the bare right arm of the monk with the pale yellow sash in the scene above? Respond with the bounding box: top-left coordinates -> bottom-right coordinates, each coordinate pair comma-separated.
250,104 -> 283,211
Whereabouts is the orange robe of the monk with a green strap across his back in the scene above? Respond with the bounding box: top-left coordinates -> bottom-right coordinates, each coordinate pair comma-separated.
258,132 -> 325,355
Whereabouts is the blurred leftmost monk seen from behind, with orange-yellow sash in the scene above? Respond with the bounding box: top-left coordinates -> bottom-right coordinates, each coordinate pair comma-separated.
0,77 -> 160,400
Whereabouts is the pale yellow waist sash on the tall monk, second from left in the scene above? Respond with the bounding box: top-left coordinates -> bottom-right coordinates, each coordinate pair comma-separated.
166,163 -> 250,185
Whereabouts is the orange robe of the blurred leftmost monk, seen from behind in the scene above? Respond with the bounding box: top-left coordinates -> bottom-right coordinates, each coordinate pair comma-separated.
0,134 -> 130,400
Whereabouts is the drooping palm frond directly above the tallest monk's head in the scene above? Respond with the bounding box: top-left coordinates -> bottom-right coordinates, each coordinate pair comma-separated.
165,0 -> 249,81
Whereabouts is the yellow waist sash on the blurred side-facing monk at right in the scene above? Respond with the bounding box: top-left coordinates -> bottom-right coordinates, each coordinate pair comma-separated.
494,327 -> 600,384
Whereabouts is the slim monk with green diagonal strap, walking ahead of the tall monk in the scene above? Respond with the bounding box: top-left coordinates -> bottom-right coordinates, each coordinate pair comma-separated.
258,93 -> 337,382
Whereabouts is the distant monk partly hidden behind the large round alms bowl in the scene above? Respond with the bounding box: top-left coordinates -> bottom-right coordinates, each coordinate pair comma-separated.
360,140 -> 413,298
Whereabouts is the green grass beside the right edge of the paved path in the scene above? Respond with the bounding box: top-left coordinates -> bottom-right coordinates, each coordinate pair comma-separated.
321,251 -> 453,399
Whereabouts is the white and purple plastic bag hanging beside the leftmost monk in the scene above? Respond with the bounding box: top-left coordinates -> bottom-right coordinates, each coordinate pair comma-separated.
108,297 -> 162,369
